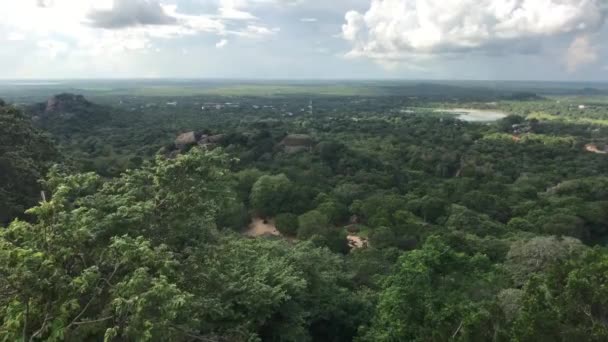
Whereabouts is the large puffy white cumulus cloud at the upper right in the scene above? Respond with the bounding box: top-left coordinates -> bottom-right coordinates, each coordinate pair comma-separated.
341,0 -> 608,62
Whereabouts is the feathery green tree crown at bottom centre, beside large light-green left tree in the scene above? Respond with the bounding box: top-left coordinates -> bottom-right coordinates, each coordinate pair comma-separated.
186,237 -> 368,341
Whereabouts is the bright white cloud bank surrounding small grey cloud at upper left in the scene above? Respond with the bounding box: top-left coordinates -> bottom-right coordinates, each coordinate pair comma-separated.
0,0 -> 279,62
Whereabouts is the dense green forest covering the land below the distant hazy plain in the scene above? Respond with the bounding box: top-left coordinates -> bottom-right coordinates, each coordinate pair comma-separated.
0,85 -> 608,342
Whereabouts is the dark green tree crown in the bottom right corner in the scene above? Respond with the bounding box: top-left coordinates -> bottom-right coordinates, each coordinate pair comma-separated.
513,249 -> 608,341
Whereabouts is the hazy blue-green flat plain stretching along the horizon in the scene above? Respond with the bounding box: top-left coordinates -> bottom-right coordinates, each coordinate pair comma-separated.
0,79 -> 608,103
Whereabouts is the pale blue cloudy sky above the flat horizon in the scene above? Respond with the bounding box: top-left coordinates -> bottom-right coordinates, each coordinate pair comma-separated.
0,0 -> 608,81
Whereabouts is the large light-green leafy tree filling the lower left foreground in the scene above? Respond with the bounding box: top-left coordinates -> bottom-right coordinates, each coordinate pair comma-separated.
0,150 -> 226,340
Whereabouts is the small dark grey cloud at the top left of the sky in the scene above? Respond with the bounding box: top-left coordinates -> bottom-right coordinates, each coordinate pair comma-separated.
87,0 -> 177,29
